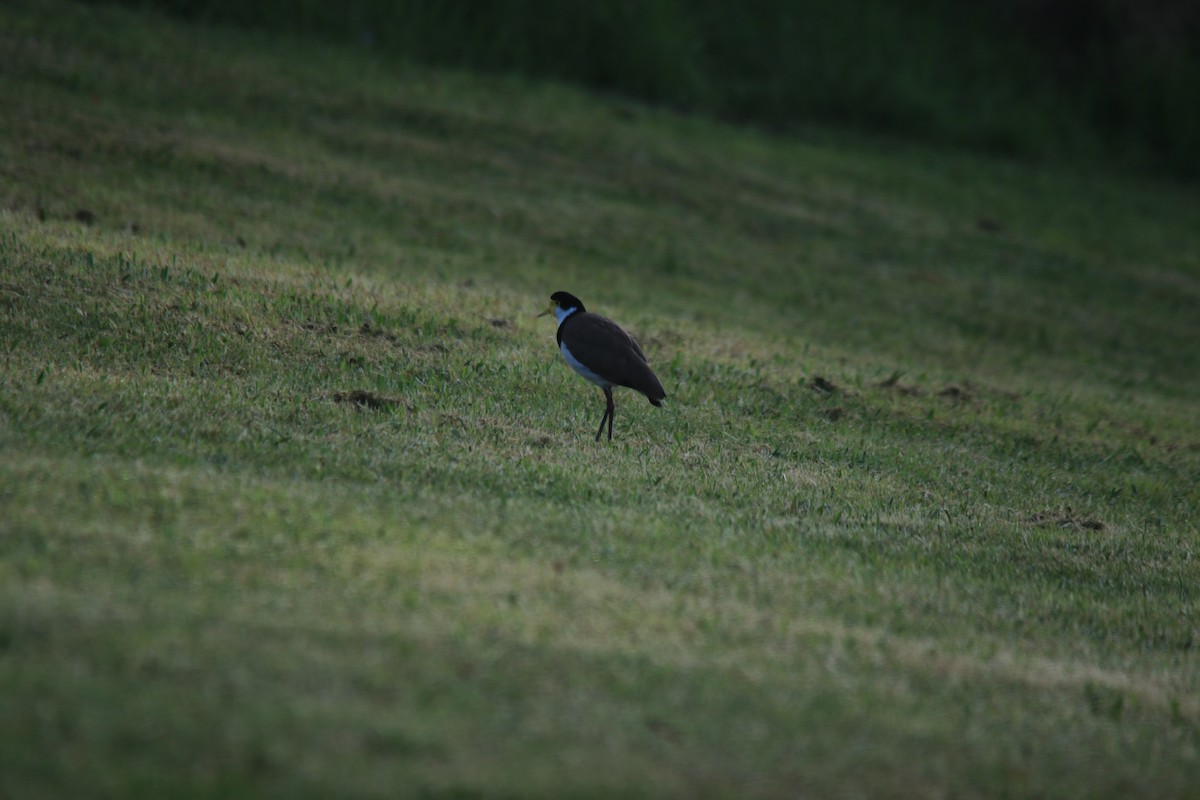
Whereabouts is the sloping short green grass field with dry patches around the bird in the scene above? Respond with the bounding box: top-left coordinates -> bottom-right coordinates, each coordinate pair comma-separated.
0,0 -> 1200,798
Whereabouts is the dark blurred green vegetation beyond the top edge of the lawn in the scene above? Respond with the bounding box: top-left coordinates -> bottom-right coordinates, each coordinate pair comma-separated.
91,0 -> 1200,178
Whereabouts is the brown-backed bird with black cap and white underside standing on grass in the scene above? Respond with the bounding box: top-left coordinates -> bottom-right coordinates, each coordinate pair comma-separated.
538,291 -> 667,441
